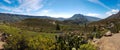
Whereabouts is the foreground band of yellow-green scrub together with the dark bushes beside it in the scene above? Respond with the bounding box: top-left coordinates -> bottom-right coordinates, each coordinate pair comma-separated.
0,25 -> 100,50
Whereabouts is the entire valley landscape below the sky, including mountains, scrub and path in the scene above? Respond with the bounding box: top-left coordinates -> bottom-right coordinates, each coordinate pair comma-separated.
0,8 -> 120,50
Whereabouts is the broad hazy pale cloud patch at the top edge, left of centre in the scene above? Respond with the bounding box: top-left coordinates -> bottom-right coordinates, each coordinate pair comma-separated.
17,0 -> 43,12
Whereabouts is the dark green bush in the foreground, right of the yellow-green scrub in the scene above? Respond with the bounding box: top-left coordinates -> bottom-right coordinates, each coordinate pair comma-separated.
56,33 -> 88,50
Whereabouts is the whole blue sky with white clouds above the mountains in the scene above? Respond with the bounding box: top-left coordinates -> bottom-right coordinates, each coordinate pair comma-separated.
0,0 -> 120,18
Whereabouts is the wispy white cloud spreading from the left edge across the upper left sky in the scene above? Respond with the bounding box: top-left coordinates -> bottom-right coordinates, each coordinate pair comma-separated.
0,0 -> 43,13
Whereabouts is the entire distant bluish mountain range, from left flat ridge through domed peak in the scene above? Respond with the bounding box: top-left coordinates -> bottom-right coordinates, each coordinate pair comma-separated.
0,13 -> 100,23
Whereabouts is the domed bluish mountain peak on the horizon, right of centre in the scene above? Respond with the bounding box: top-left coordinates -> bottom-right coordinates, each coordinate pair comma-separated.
64,14 -> 100,24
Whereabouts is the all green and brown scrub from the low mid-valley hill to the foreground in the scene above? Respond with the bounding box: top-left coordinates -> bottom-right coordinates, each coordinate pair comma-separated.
0,19 -> 120,50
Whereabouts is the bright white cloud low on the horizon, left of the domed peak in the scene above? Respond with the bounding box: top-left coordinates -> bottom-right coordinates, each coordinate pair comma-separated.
33,9 -> 73,18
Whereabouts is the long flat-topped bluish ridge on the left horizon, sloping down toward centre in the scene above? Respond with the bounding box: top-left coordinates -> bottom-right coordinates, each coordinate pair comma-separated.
0,13 -> 65,22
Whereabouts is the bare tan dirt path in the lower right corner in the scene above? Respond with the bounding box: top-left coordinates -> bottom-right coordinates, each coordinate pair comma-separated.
98,33 -> 120,50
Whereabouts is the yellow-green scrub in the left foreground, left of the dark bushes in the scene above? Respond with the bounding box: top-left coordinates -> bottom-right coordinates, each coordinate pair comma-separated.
0,25 -> 55,50
